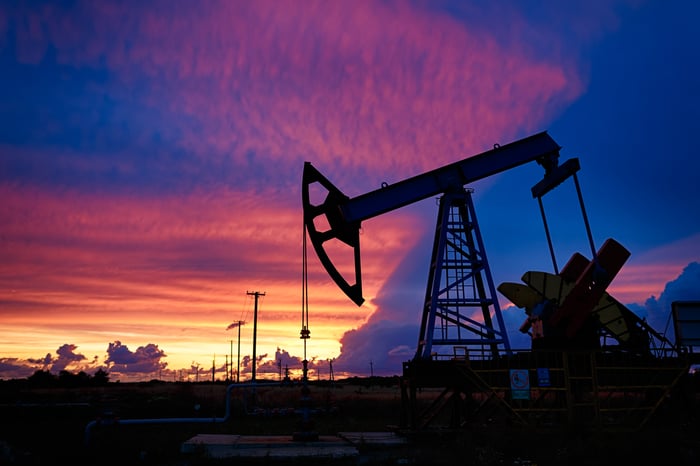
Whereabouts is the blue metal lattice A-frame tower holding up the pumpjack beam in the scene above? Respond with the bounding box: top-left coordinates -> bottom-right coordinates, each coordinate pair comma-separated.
416,189 -> 510,360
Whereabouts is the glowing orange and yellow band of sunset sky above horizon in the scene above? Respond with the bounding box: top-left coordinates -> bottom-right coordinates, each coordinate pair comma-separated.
0,181 -> 402,369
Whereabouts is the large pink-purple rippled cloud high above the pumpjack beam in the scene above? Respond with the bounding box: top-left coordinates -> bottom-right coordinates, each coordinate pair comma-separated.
5,1 -> 583,184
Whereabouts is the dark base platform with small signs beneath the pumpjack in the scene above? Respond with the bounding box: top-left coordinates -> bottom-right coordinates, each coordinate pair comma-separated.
400,350 -> 693,434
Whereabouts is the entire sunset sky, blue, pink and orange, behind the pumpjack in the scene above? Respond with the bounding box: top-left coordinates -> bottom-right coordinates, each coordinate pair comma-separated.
0,0 -> 700,381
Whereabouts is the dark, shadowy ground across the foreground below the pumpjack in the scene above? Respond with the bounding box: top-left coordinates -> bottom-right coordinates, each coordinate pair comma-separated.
0,379 -> 700,466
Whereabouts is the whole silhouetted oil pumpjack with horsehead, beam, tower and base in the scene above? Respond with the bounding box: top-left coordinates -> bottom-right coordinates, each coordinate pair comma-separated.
302,132 -> 690,431
